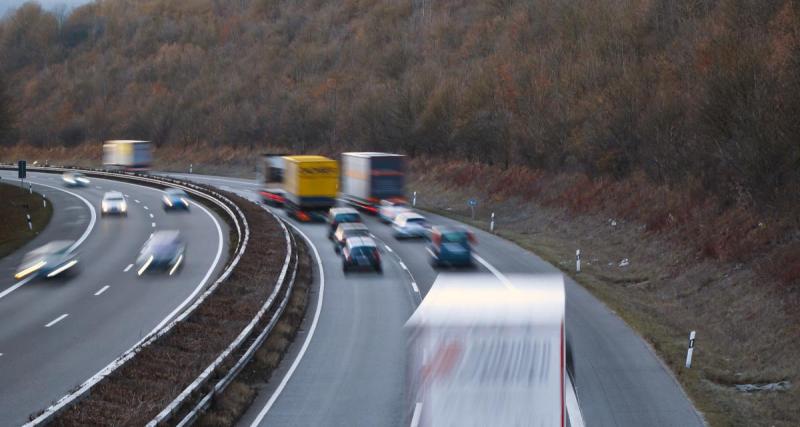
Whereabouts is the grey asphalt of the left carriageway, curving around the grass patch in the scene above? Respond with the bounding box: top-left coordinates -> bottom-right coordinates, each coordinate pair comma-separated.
0,171 -> 228,425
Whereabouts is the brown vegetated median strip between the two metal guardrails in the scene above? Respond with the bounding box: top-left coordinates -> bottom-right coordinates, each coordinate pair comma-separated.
54,194 -> 286,425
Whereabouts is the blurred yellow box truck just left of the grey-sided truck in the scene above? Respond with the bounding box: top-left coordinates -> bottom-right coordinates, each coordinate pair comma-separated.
283,156 -> 339,221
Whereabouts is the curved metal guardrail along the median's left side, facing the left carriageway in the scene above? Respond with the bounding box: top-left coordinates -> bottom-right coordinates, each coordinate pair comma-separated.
0,165 -> 250,426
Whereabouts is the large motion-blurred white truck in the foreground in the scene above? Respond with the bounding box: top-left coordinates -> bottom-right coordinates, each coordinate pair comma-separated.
406,274 -> 567,427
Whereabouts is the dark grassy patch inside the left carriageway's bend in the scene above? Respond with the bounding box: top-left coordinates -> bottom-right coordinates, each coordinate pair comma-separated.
0,184 -> 53,258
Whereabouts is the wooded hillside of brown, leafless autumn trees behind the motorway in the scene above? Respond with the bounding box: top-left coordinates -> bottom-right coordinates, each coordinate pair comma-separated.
0,0 -> 800,208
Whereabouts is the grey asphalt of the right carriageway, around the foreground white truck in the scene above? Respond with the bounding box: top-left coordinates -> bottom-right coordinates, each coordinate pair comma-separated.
164,174 -> 704,426
